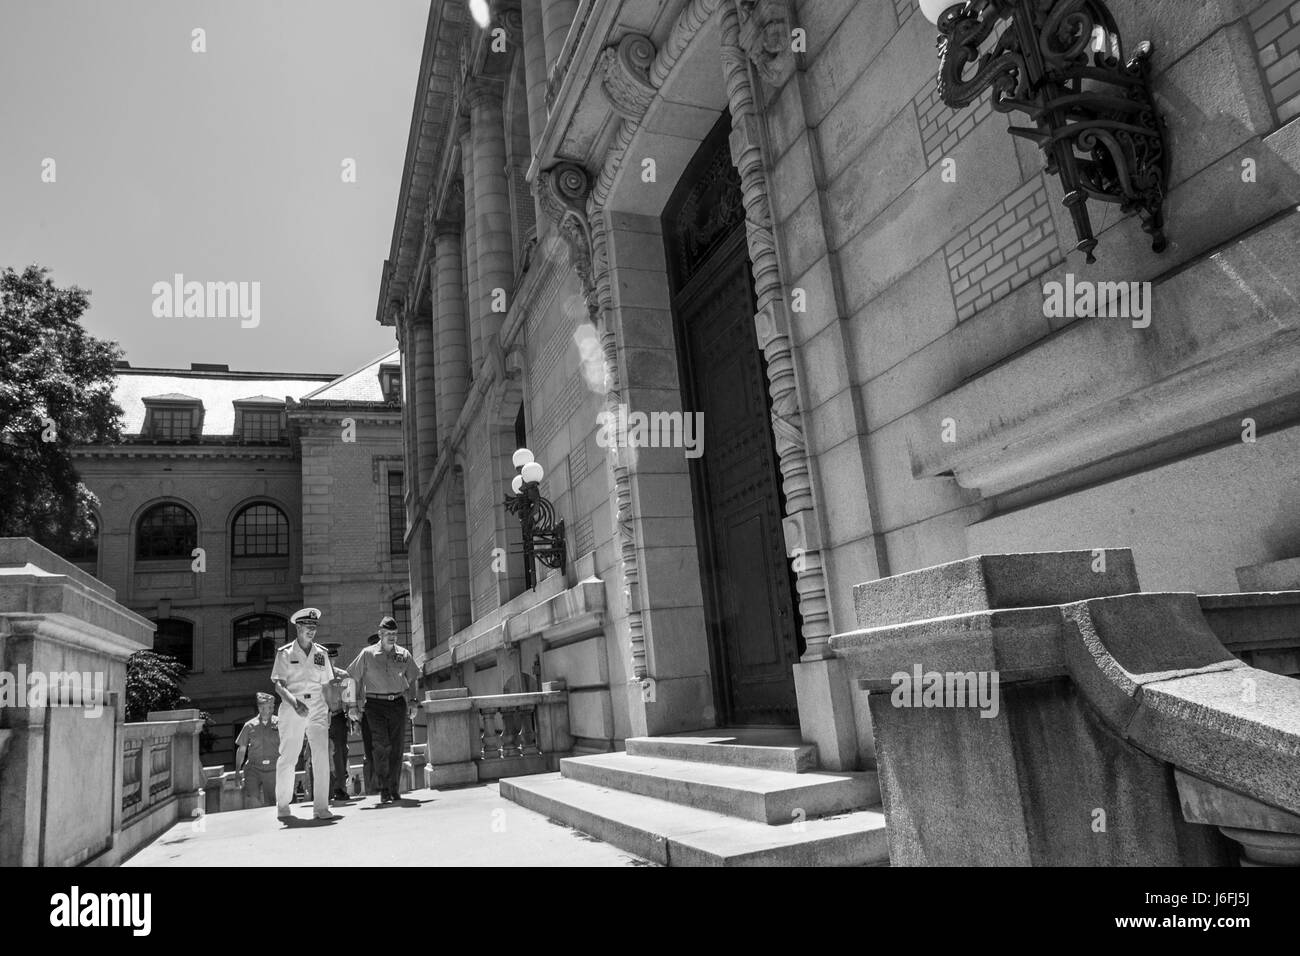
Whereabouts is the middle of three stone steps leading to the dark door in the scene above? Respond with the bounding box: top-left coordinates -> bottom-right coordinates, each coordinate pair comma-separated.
560,753 -> 880,823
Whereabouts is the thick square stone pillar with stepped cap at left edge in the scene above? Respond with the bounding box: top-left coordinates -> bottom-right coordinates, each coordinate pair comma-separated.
0,537 -> 152,866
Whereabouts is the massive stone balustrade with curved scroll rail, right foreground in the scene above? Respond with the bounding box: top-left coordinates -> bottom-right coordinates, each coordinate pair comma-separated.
831,550 -> 1300,866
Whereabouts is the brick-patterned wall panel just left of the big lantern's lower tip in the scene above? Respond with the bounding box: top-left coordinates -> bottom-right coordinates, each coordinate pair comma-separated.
944,176 -> 1062,320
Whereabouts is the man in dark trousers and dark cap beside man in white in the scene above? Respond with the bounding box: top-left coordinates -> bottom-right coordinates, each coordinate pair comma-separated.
347,618 -> 420,804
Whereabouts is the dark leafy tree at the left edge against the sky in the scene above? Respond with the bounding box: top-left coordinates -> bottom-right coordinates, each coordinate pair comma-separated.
0,265 -> 122,553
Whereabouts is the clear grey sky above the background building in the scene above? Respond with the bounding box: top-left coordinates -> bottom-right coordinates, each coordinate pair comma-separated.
0,0 -> 429,373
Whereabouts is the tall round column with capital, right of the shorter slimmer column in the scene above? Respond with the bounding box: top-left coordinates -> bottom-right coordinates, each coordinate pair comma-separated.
465,79 -> 515,356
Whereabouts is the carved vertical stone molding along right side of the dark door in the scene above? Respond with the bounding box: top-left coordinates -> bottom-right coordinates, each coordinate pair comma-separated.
722,0 -> 831,659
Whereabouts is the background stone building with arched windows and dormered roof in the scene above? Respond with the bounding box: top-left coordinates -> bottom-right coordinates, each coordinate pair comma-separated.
70,354 -> 407,765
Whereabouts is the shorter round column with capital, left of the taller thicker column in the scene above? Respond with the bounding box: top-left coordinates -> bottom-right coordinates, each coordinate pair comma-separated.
429,220 -> 469,442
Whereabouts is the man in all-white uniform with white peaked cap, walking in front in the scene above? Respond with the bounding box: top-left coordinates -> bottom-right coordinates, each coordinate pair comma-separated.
270,607 -> 334,819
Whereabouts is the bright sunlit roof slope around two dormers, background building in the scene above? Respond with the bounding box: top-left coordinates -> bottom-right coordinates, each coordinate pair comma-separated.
113,368 -> 335,437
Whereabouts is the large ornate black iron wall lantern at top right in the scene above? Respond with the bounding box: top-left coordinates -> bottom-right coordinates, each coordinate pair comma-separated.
919,0 -> 1169,263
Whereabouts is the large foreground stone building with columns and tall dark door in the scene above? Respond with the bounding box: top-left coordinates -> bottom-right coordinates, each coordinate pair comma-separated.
377,0 -> 1300,770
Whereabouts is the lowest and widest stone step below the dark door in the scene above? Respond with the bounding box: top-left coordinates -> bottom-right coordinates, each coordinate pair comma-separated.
501,774 -> 889,866
